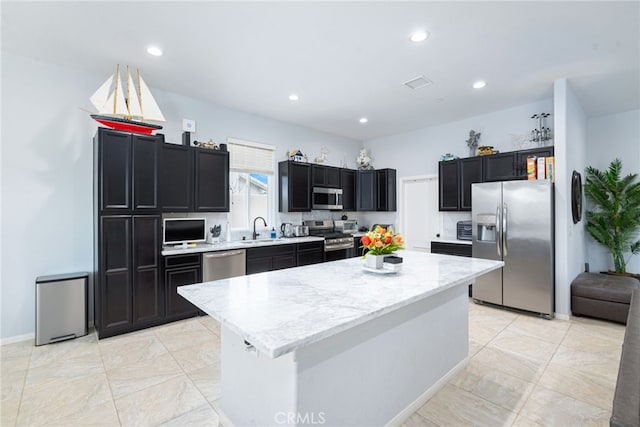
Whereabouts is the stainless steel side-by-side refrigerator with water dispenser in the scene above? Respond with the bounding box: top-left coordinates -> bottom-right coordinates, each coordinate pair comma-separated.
471,180 -> 555,317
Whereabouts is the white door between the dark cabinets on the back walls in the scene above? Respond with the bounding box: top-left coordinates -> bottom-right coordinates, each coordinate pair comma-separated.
400,176 -> 441,252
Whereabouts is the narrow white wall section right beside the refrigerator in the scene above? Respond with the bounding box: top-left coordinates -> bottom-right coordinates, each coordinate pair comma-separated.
554,79 -> 587,318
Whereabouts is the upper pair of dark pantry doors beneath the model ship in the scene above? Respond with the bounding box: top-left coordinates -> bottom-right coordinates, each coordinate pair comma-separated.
95,128 -> 163,213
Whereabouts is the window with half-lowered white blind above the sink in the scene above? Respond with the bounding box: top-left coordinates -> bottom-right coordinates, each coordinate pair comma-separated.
227,138 -> 275,229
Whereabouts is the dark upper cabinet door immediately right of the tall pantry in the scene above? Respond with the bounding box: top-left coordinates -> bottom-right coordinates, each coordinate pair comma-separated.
159,144 -> 194,212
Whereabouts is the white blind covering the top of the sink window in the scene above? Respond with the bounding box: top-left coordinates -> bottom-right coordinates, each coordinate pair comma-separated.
227,138 -> 276,175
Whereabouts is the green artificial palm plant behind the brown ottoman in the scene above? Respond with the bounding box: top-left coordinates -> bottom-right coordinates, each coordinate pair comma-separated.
585,159 -> 640,273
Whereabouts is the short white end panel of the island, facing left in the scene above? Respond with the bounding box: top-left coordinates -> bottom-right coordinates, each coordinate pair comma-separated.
220,325 -> 297,426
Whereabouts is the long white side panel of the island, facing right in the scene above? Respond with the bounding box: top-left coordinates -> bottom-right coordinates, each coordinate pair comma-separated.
296,285 -> 469,425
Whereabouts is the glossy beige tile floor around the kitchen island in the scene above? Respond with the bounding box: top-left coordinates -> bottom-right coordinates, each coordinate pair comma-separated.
0,303 -> 624,427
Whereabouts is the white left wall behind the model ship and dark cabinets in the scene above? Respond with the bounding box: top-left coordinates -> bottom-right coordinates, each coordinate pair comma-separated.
0,52 -> 361,342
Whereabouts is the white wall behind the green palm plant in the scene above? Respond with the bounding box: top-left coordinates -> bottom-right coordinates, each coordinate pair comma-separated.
586,110 -> 640,273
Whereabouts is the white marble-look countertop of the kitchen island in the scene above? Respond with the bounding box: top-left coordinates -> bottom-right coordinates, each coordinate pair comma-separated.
178,251 -> 503,358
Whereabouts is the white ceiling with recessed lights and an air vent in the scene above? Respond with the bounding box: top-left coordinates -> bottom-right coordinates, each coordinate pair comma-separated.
1,1 -> 640,140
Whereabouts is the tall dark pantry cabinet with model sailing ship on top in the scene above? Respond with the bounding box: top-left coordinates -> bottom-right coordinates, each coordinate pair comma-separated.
94,128 -> 164,338
